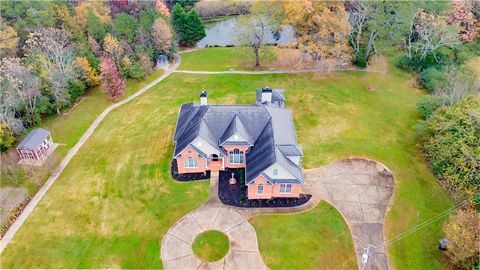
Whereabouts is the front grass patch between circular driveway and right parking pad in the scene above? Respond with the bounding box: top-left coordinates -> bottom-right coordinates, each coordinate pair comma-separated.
250,201 -> 357,269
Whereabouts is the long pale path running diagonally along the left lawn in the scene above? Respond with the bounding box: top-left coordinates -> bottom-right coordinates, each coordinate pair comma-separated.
0,55 -> 181,253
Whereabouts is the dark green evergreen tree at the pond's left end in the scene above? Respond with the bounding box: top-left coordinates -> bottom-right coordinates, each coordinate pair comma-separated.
172,4 -> 207,46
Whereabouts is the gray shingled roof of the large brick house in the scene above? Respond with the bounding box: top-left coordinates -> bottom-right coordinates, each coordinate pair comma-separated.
174,100 -> 303,183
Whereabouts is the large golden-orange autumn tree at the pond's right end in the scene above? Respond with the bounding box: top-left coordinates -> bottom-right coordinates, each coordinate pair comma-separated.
283,0 -> 350,65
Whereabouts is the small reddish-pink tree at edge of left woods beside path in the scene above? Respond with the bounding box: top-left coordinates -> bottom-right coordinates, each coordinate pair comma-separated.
100,57 -> 125,100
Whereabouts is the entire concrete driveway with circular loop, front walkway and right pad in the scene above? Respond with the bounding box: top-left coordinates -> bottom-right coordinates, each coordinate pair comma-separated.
161,158 -> 394,269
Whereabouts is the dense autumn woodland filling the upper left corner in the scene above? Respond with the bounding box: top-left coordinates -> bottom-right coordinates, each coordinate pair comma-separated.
0,0 -> 205,152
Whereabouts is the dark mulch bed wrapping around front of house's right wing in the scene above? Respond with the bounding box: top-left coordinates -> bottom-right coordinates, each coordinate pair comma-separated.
218,169 -> 312,208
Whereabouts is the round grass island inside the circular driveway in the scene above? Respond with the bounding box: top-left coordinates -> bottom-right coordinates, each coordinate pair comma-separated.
192,230 -> 230,262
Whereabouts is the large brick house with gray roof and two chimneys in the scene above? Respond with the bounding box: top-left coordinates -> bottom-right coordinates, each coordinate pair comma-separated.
173,87 -> 303,199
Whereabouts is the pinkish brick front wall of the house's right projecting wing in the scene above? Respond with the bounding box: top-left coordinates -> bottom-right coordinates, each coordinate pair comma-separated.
248,176 -> 301,199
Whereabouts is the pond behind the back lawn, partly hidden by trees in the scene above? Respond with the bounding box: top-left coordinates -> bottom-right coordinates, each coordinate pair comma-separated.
197,17 -> 295,47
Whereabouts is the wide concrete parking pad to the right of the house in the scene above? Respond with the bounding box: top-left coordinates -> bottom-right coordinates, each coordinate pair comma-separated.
304,158 -> 395,269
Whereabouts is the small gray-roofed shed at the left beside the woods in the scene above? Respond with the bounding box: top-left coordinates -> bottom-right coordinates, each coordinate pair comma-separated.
17,128 -> 58,166
